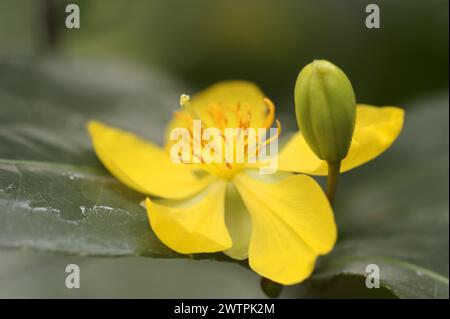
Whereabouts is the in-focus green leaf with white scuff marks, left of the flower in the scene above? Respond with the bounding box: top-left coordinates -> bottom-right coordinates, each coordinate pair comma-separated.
0,160 -> 177,257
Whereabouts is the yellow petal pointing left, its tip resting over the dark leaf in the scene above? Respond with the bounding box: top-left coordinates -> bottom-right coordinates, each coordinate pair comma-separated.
88,121 -> 211,199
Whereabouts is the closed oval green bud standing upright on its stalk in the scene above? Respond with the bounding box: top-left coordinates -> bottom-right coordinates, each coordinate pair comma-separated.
295,60 -> 356,162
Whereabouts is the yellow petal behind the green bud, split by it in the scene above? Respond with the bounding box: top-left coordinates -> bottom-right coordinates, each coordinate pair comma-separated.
278,104 -> 404,175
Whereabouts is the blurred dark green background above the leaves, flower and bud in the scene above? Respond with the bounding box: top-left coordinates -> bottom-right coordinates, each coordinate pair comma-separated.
0,0 -> 449,110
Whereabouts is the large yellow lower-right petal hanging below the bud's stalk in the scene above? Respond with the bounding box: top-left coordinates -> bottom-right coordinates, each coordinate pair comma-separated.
233,174 -> 337,285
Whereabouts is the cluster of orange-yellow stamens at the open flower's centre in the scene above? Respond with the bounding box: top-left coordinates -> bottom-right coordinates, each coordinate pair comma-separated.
168,95 -> 281,180
